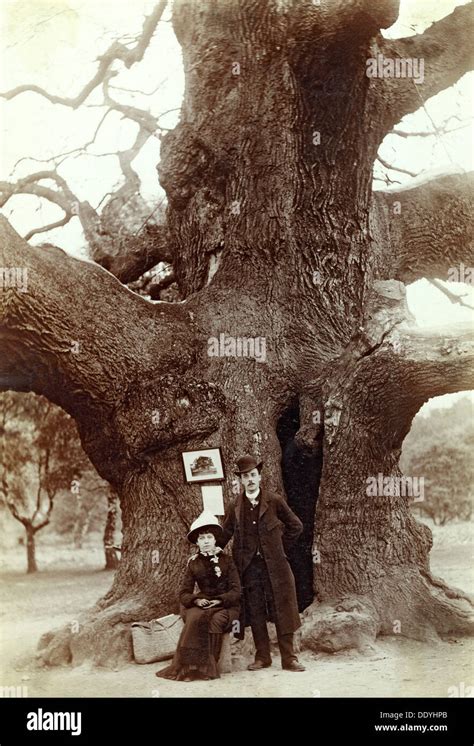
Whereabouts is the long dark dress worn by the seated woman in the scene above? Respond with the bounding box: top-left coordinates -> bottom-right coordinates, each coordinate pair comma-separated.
156,553 -> 240,681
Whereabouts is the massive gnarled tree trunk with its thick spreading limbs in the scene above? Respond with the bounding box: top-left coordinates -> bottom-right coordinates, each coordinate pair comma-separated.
0,0 -> 473,664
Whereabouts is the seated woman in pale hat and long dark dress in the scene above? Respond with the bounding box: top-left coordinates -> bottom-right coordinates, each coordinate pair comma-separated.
156,511 -> 240,681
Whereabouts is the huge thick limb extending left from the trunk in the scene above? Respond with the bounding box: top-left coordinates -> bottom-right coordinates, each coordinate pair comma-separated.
0,218 -> 193,420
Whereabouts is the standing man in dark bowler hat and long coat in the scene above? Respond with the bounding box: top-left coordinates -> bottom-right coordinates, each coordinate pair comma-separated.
223,455 -> 305,671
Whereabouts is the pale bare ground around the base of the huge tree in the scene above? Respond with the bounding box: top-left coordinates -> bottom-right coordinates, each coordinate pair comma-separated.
0,523 -> 474,697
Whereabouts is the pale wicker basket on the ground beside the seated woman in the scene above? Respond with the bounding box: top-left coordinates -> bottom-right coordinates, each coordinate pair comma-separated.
132,614 -> 184,663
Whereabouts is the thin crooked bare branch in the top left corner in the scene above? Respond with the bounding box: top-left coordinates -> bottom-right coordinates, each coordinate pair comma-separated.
0,0 -> 166,109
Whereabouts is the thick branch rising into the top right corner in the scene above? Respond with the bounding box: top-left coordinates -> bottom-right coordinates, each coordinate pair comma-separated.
378,2 -> 474,132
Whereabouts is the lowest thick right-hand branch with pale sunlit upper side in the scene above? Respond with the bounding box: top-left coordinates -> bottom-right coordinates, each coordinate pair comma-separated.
336,322 -> 474,456
